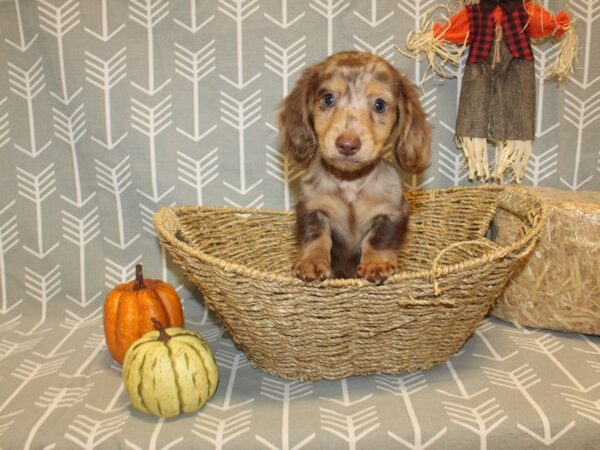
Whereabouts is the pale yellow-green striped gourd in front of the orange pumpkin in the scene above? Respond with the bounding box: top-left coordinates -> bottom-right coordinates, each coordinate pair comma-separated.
123,319 -> 219,417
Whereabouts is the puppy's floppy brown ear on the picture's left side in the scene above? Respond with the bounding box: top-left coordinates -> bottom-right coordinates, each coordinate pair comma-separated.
279,65 -> 319,165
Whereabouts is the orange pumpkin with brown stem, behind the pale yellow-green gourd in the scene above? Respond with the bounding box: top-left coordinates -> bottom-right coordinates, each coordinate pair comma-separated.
104,264 -> 183,364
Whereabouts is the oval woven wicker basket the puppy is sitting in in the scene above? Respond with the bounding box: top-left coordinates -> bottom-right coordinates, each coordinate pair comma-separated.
154,186 -> 546,380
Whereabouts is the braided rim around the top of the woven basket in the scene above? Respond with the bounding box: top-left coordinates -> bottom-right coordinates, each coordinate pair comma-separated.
154,185 -> 547,288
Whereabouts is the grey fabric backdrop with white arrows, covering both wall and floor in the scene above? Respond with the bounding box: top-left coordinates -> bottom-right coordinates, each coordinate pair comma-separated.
0,0 -> 600,449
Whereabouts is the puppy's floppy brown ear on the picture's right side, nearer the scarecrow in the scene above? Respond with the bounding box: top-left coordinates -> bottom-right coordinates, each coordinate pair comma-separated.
393,73 -> 431,173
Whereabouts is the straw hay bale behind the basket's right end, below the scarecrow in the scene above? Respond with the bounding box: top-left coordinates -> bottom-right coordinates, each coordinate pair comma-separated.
491,188 -> 600,334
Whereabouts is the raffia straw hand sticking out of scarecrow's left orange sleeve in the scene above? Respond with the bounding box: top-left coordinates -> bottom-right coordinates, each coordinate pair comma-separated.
395,5 -> 468,79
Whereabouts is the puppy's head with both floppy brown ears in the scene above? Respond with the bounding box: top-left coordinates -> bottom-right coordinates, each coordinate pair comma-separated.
279,52 -> 431,173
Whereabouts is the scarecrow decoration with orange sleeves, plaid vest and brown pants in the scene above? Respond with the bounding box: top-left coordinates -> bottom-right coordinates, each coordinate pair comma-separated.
402,0 -> 577,182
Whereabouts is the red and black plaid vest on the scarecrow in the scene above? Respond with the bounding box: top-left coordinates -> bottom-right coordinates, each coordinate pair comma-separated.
467,4 -> 533,64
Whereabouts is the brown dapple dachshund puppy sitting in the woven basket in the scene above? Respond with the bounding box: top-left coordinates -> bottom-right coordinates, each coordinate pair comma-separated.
279,52 -> 431,284
